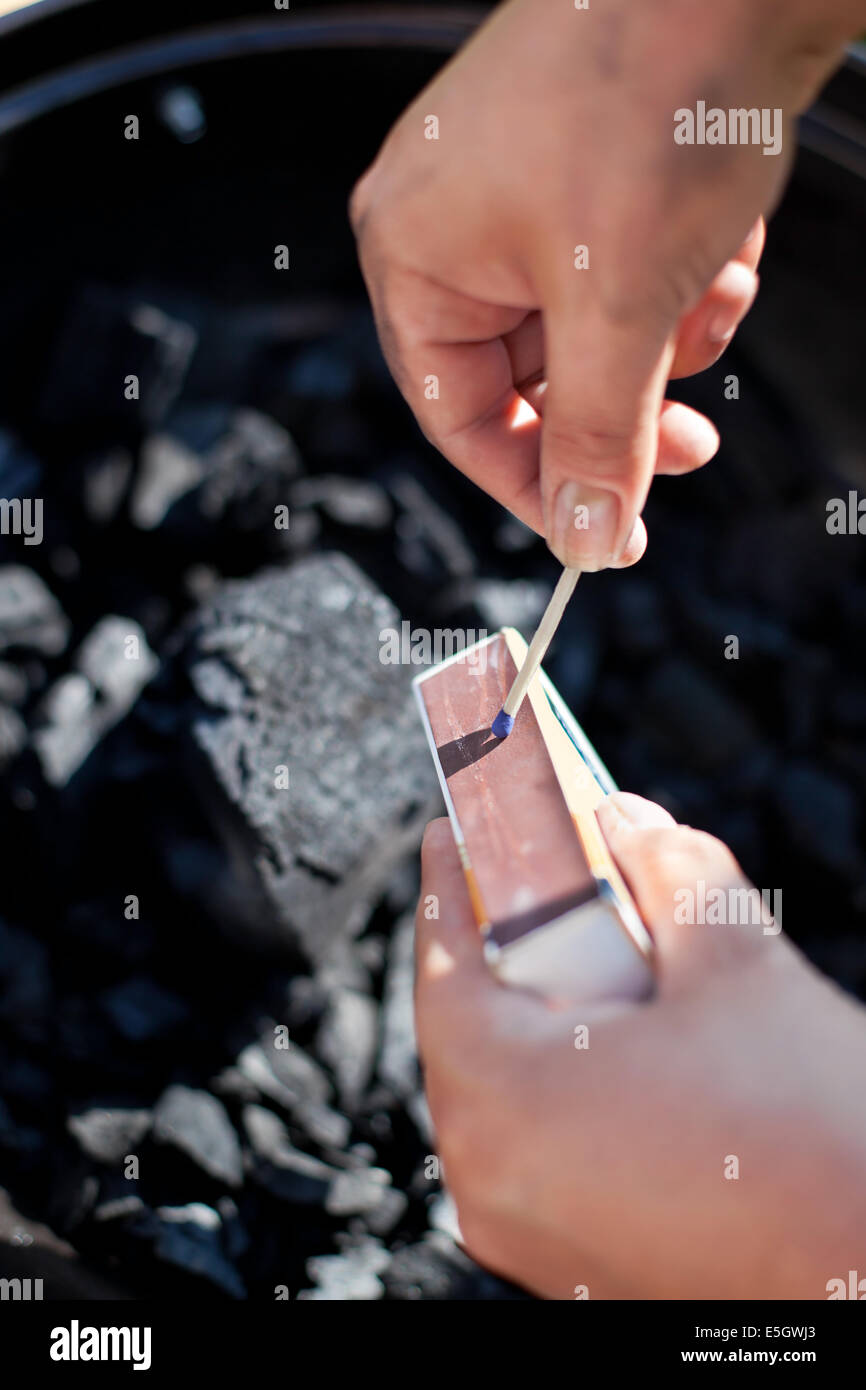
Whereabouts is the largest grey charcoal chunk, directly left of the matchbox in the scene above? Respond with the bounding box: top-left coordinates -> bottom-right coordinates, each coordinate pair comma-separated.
188,556 -> 436,960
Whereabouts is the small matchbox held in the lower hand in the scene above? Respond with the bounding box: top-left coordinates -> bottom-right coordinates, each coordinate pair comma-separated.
413,628 -> 652,1002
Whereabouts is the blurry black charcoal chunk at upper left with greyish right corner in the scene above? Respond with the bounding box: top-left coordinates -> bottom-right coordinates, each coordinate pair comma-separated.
39,285 -> 197,439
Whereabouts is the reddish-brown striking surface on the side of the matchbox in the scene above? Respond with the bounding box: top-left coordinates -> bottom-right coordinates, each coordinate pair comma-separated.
421,635 -> 596,945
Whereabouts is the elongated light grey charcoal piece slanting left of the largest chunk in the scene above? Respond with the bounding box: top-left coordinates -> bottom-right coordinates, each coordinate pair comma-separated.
33,616 -> 158,787
